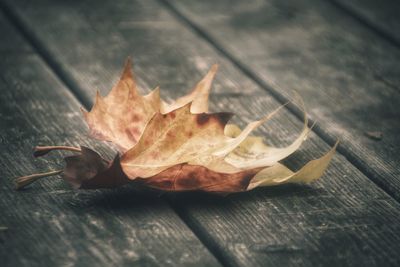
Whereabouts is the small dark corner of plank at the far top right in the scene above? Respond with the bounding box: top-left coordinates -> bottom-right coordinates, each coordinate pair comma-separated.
331,0 -> 400,46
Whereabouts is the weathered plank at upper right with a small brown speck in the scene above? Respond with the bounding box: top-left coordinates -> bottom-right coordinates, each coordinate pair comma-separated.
167,0 -> 400,200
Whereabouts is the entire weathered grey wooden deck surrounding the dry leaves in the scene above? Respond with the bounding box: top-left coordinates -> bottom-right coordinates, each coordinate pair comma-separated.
0,0 -> 400,267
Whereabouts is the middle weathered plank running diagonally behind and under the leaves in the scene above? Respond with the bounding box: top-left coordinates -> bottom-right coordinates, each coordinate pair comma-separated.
2,0 -> 400,266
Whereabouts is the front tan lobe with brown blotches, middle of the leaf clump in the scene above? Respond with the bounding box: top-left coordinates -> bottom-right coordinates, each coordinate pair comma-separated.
121,103 -> 281,179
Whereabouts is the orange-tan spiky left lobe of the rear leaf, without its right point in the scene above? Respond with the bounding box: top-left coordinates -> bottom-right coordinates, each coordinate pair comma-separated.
82,59 -> 160,151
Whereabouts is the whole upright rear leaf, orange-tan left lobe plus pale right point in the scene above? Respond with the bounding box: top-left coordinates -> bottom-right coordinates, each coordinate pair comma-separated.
82,58 -> 218,152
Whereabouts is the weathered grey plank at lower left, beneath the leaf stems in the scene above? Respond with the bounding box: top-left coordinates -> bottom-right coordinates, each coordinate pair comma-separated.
0,10 -> 219,266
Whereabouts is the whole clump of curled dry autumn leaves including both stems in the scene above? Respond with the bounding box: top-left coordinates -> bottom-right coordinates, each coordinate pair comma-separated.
16,58 -> 337,193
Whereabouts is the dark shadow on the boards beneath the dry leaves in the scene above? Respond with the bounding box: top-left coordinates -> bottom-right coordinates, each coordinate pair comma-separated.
74,184 -> 321,210
